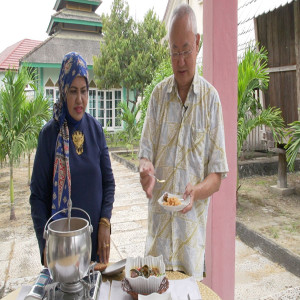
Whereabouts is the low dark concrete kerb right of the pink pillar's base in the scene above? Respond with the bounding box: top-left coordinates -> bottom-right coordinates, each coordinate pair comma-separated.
236,221 -> 300,277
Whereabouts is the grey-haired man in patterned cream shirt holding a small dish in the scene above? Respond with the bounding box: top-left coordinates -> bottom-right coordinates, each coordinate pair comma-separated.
139,4 -> 228,280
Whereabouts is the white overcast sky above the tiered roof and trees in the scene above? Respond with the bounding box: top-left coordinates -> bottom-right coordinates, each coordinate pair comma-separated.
0,0 -> 168,52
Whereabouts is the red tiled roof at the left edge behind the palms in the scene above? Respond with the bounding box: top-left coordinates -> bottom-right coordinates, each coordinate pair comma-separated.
0,39 -> 42,71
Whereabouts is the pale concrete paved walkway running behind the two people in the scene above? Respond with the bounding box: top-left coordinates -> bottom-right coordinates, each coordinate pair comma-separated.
0,160 -> 300,300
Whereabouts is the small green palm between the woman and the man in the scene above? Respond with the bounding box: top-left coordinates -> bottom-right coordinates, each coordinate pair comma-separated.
119,102 -> 140,158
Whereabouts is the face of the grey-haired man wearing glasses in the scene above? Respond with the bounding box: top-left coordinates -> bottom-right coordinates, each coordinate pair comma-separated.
169,16 -> 200,89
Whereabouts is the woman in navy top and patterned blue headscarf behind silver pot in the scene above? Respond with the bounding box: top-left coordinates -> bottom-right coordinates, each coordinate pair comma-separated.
30,52 -> 115,265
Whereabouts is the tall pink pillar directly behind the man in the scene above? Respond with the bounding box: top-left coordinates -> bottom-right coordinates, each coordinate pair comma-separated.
203,0 -> 237,300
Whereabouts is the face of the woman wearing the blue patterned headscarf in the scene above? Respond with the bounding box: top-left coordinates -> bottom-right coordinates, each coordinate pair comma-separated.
67,76 -> 88,121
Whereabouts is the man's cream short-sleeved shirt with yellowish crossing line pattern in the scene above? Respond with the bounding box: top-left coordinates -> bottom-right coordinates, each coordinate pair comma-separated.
139,72 -> 228,280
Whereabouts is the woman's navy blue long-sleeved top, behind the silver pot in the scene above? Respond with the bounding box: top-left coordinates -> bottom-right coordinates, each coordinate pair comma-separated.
29,113 -> 115,264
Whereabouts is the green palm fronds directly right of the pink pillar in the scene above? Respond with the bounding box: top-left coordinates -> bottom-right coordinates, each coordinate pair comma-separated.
237,47 -> 284,157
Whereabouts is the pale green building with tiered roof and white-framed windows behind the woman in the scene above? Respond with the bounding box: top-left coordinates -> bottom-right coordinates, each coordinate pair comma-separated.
21,0 -> 126,131
